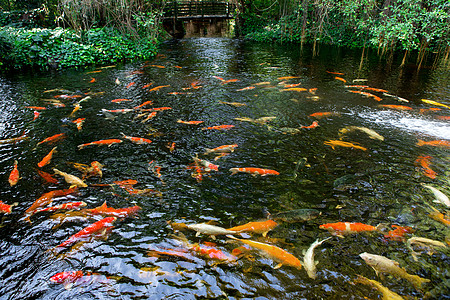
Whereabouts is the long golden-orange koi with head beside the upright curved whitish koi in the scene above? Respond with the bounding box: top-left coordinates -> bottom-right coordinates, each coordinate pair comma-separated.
227,235 -> 302,269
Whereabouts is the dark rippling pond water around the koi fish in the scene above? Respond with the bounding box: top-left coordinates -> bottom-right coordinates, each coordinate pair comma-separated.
0,38 -> 450,299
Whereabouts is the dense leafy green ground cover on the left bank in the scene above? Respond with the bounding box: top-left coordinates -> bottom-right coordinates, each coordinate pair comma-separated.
0,27 -> 156,69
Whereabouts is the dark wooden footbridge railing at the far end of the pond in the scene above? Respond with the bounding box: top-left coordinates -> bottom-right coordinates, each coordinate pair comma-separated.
164,1 -> 235,20
